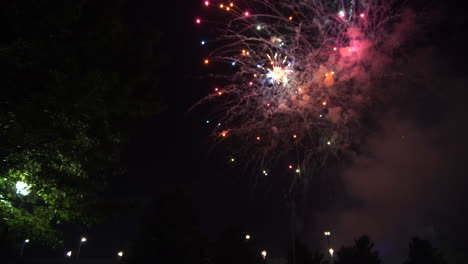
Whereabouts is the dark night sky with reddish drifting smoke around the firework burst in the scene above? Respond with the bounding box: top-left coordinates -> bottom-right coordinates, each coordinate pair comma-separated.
12,1 -> 468,263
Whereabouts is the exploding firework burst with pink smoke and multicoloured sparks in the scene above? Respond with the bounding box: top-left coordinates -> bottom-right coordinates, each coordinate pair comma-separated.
196,0 -> 414,183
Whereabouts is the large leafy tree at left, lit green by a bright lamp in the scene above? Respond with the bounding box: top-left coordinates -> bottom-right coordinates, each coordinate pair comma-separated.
0,0 -> 163,244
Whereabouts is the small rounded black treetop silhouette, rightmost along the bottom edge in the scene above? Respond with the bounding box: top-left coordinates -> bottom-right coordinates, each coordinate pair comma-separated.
404,237 -> 446,264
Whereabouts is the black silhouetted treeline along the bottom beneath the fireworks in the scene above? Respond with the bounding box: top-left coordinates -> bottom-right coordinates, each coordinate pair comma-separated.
126,193 -> 446,264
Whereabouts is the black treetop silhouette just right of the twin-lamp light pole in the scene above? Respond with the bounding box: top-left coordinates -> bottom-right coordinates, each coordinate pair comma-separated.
335,236 -> 381,264
